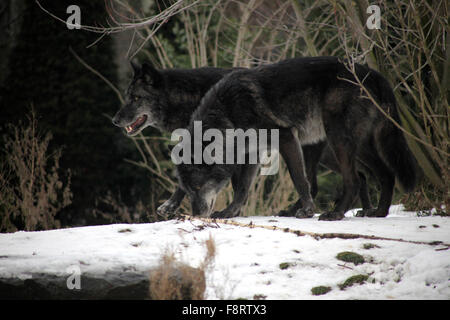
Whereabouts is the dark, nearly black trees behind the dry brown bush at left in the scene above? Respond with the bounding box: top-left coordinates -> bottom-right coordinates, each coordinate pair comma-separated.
0,0 -> 152,229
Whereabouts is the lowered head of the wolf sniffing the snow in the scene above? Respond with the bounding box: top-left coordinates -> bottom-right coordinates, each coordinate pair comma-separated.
177,164 -> 235,216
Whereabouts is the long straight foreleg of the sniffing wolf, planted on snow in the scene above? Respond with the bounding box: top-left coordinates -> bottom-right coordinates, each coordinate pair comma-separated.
279,129 -> 314,218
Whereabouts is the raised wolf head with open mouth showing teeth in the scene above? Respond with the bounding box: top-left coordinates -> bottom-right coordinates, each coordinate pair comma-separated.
112,62 -> 167,136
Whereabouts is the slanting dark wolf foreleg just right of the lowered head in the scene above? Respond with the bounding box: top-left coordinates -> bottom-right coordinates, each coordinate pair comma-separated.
211,164 -> 259,218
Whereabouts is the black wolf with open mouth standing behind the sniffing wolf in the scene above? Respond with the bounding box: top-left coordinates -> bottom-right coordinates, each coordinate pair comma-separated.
113,63 -> 412,220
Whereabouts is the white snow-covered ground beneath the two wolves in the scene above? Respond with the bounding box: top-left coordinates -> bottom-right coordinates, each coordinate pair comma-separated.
0,206 -> 450,299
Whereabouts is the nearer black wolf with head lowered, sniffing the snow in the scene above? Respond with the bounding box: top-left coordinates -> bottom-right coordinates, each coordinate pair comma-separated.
177,57 -> 416,220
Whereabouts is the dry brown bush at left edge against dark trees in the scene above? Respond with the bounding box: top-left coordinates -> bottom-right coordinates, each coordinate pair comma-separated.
0,112 -> 72,232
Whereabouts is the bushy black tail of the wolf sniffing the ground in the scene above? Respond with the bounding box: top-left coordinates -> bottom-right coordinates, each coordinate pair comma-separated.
375,89 -> 418,192
